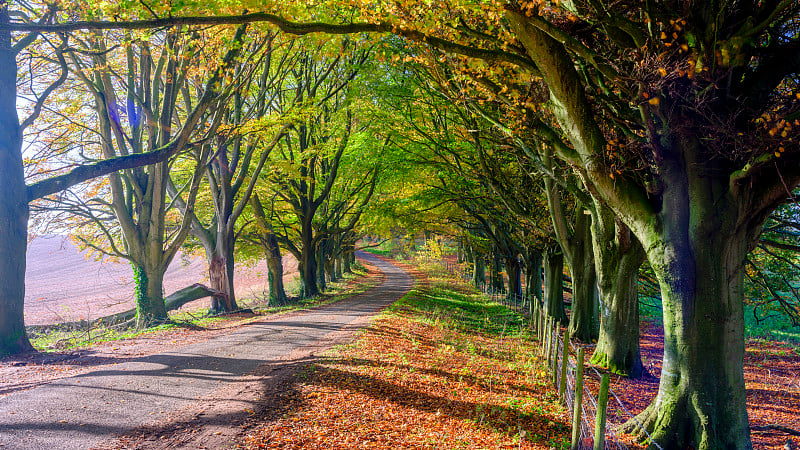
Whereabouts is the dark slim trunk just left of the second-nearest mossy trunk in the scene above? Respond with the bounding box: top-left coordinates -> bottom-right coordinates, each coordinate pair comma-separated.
569,214 -> 600,342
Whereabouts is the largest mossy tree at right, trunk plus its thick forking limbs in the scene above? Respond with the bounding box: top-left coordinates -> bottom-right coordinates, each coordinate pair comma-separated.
506,10 -> 780,450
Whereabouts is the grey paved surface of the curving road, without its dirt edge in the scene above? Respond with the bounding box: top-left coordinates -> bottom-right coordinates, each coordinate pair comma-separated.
0,253 -> 412,450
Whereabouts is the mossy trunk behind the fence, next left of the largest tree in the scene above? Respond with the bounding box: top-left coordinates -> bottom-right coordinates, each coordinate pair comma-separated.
591,206 -> 647,378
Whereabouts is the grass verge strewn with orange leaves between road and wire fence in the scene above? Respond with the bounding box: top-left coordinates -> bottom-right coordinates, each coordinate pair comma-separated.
242,256 -> 569,449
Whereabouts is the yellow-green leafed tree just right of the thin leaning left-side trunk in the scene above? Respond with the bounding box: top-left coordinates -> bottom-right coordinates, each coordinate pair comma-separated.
266,38 -> 369,298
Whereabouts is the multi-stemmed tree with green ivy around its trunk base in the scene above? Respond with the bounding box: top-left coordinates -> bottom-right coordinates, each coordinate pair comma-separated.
53,26 -> 218,328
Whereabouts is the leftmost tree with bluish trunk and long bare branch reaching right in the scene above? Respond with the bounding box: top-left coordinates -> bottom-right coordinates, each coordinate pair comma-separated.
0,1 -> 245,355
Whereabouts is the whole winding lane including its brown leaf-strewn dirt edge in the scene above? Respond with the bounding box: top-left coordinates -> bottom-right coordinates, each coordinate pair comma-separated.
0,256 -> 411,450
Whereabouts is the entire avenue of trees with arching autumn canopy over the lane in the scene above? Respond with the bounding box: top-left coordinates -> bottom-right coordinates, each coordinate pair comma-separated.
0,0 -> 800,449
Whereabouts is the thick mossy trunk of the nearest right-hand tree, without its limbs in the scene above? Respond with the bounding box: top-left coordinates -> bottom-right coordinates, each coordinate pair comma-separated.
626,141 -> 756,450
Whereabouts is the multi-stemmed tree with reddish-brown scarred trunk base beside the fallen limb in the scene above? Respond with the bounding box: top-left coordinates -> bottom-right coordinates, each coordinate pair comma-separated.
168,32 -> 292,313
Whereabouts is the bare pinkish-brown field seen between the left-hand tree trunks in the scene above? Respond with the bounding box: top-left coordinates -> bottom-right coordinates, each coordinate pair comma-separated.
25,236 -> 297,325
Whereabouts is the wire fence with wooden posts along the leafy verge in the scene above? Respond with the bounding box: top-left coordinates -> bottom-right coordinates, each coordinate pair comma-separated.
437,255 -> 661,450
